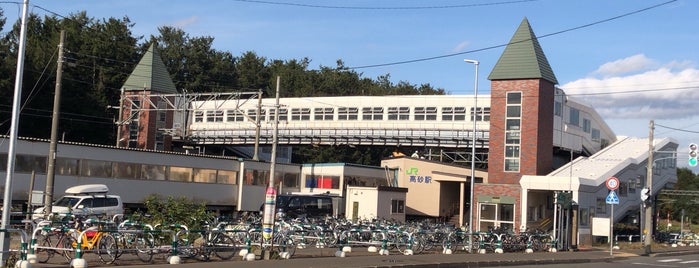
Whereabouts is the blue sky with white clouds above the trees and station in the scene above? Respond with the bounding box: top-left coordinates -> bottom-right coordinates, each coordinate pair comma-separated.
0,0 -> 699,172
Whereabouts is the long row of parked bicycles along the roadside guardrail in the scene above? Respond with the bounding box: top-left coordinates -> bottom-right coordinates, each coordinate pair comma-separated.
1,213 -> 696,267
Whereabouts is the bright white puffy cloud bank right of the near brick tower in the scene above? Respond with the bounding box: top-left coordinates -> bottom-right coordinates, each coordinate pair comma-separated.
561,55 -> 699,119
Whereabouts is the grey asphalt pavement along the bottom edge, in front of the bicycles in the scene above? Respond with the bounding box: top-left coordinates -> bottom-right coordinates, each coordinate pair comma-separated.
32,245 -> 699,268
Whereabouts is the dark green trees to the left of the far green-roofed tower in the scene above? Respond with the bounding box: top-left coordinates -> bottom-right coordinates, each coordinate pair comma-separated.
0,12 -> 138,144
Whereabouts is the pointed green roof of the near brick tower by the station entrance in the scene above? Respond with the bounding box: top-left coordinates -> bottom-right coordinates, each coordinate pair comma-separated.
488,17 -> 558,85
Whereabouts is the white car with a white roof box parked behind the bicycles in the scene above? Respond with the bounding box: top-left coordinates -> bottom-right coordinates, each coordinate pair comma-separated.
32,184 -> 124,219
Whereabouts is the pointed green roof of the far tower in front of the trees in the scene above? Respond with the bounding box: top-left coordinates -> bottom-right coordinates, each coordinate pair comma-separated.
122,44 -> 177,94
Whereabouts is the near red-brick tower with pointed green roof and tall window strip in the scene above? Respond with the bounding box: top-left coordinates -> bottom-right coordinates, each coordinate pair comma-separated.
472,18 -> 558,231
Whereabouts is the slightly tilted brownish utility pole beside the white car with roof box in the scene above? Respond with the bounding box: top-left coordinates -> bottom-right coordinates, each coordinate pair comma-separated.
44,30 -> 66,219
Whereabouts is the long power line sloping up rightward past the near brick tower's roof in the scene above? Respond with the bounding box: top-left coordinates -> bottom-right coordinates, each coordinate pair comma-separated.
348,0 -> 677,69
